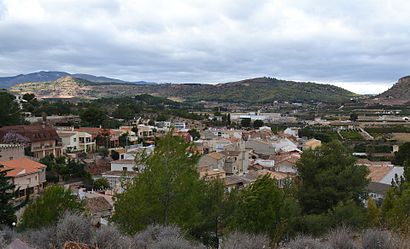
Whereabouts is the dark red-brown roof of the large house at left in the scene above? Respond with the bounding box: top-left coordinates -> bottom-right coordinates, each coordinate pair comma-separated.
0,125 -> 59,142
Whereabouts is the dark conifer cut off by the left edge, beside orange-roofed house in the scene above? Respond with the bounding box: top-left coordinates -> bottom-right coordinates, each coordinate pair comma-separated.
0,165 -> 16,227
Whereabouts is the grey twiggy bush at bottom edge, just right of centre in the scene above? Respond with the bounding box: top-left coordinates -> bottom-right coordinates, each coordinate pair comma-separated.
222,232 -> 269,249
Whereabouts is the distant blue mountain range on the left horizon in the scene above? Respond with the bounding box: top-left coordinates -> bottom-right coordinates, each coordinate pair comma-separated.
0,71 -> 152,88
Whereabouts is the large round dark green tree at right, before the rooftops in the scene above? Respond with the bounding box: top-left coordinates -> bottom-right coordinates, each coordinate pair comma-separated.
297,140 -> 368,214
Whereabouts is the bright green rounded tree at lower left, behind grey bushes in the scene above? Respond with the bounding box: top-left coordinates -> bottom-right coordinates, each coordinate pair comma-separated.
19,185 -> 84,229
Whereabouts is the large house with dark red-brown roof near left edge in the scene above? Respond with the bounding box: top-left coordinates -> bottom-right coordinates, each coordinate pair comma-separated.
0,125 -> 62,159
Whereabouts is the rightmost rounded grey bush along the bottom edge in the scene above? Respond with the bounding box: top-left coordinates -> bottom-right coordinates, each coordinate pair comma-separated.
362,229 -> 399,249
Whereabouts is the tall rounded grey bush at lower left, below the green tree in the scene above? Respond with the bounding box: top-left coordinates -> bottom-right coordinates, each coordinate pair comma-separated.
56,212 -> 92,246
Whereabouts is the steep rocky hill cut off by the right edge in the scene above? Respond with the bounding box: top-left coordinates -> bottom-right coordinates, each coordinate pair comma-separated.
375,76 -> 410,105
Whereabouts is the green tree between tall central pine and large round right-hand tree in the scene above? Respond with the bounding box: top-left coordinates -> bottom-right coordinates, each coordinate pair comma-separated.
228,175 -> 283,238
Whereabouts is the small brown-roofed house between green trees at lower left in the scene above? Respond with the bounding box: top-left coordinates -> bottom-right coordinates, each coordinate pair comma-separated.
85,196 -> 113,226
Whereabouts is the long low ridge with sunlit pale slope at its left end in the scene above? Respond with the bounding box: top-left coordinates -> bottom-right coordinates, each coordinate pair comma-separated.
10,76 -> 357,104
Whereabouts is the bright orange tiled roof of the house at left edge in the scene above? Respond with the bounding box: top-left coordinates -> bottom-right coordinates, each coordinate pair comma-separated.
1,157 -> 46,177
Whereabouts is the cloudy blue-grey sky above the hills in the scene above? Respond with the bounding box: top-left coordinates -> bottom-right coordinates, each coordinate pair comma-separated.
0,0 -> 410,93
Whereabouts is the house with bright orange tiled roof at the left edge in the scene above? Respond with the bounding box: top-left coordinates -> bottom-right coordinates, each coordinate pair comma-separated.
1,157 -> 47,198
